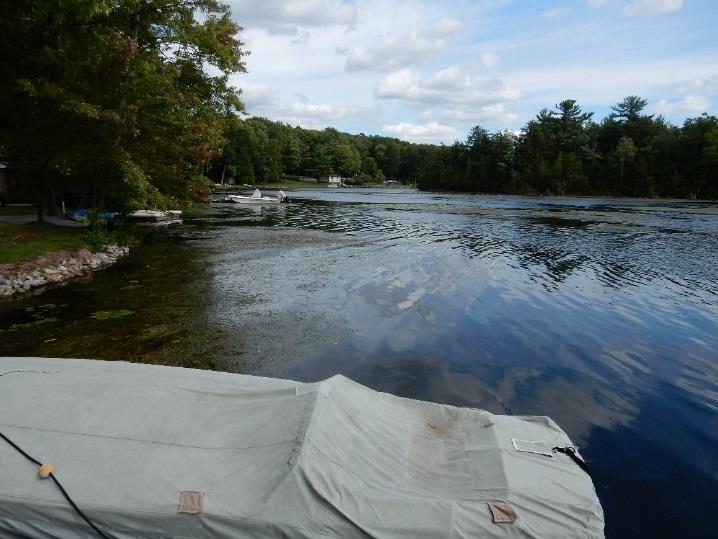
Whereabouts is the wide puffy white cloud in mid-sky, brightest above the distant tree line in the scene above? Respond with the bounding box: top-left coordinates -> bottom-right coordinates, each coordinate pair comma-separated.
376,66 -> 521,107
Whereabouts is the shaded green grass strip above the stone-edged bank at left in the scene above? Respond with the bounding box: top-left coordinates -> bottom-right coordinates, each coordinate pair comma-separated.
0,222 -> 85,264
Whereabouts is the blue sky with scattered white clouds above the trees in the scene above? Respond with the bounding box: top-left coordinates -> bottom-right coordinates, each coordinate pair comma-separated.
225,0 -> 718,144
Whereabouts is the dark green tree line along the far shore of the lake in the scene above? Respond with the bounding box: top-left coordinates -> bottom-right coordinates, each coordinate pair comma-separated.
217,96 -> 718,198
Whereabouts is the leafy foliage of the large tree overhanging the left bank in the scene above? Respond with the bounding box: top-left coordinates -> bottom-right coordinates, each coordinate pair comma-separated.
0,0 -> 244,215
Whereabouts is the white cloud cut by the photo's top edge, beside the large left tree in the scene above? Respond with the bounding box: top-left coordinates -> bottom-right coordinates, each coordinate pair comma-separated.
229,0 -> 357,35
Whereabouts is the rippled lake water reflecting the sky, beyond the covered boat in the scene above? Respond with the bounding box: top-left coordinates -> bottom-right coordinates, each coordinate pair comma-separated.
0,189 -> 718,537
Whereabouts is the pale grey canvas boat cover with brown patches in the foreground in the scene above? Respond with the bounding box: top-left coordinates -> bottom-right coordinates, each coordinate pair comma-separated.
0,358 -> 603,539
